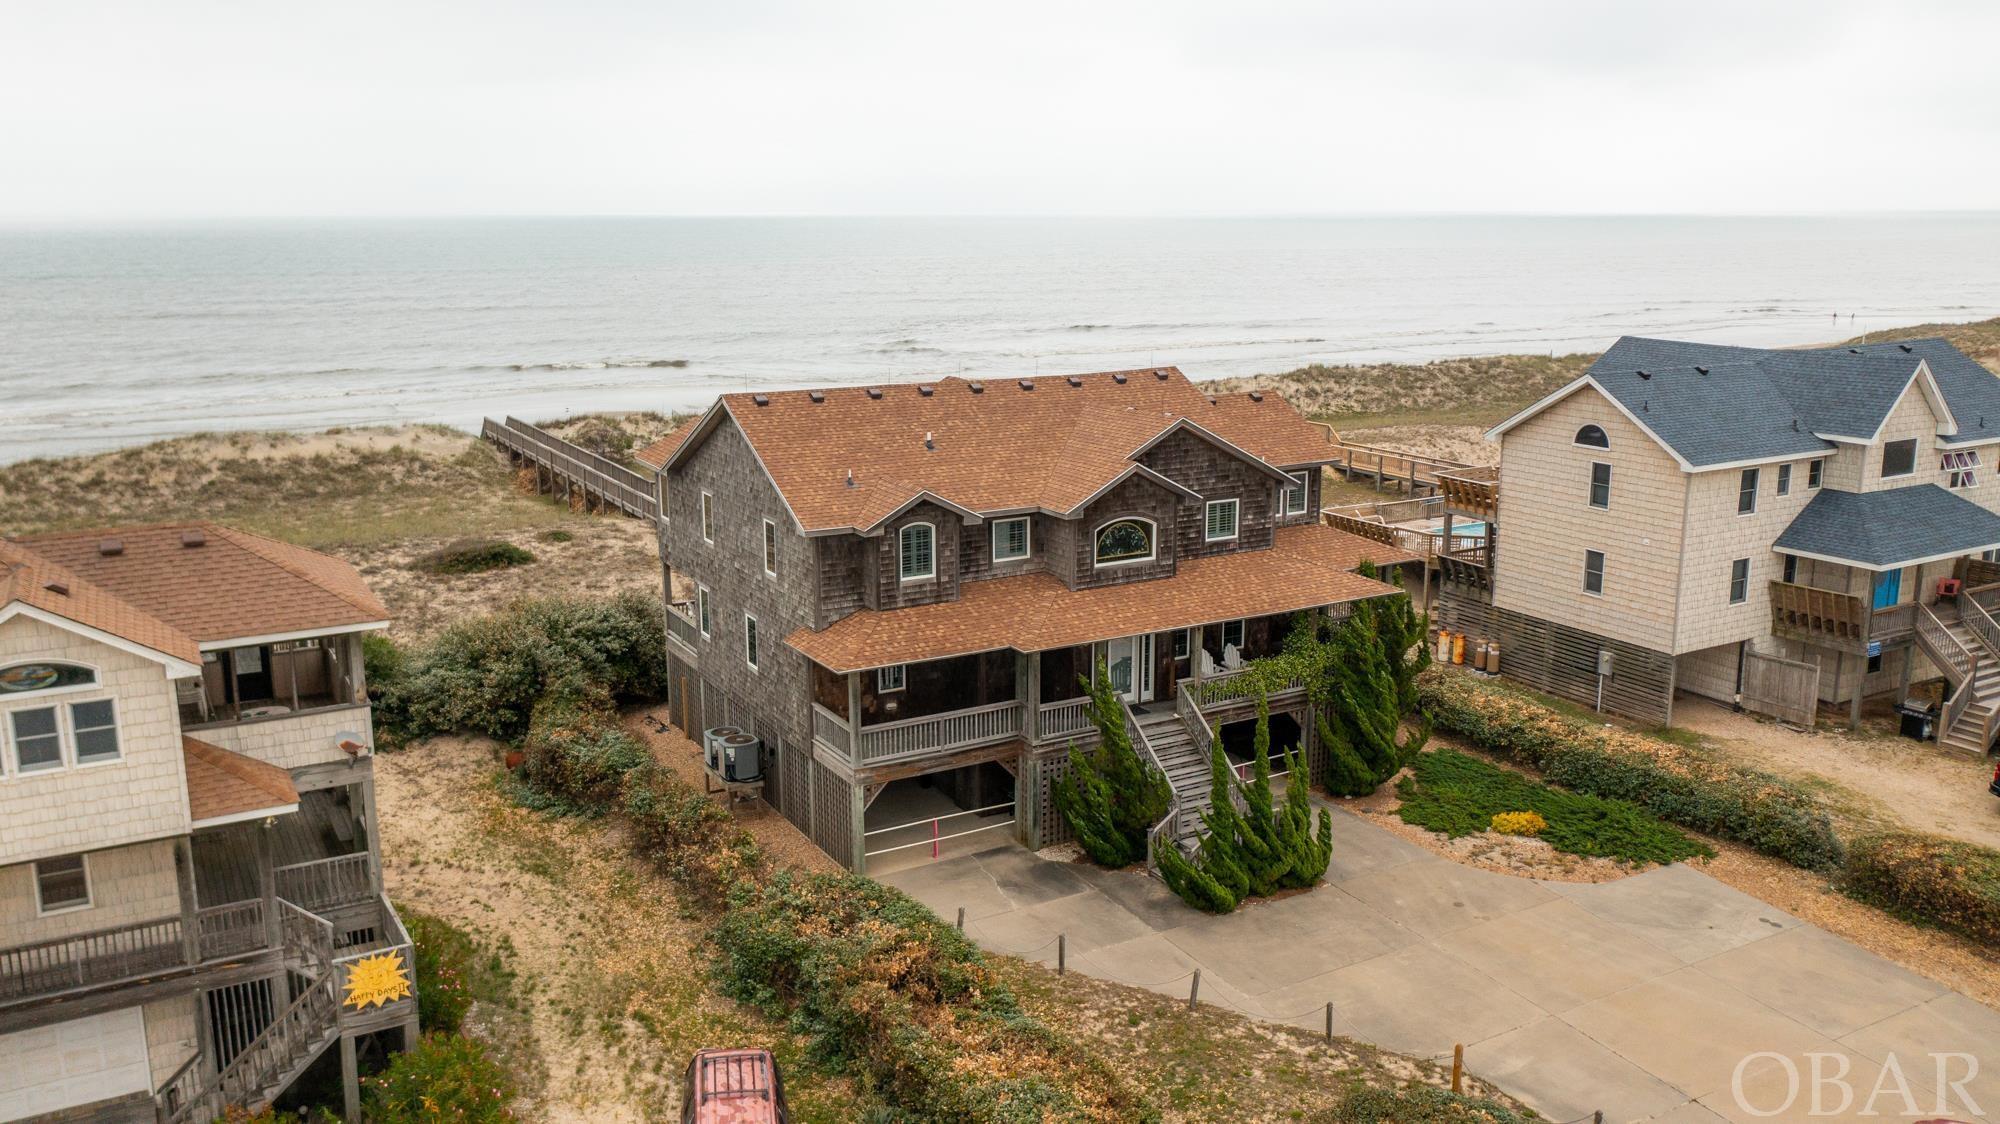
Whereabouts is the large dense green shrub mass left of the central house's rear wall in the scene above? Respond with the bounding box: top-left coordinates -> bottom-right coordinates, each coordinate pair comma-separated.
376,590 -> 666,742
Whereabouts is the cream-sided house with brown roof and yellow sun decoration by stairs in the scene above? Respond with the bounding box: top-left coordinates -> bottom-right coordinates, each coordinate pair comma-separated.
0,522 -> 416,1122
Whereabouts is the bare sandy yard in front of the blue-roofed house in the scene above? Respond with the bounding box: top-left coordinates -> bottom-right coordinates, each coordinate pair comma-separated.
1674,696 -> 2000,846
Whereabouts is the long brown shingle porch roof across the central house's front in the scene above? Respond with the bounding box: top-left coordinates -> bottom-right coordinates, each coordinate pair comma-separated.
786,524 -> 1416,672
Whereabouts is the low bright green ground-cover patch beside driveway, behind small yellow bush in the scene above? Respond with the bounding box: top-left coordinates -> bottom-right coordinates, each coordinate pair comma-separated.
1396,750 -> 1714,864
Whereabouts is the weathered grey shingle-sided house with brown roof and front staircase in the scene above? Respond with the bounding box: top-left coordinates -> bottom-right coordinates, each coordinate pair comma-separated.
640,368 -> 1412,870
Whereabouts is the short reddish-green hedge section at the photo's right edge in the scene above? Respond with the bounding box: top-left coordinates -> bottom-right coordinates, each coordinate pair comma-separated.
1840,832 -> 2000,948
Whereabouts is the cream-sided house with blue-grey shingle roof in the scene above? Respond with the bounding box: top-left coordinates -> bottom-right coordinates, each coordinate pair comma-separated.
1444,336 -> 2000,750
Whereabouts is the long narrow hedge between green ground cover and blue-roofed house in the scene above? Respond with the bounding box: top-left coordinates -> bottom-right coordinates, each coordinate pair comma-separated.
1418,668 -> 1844,870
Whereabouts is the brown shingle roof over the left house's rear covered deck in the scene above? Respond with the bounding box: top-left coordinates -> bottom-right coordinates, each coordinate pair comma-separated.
14,522 -> 388,642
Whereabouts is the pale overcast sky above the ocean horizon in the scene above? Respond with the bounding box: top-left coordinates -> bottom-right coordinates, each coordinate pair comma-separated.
0,0 -> 2000,222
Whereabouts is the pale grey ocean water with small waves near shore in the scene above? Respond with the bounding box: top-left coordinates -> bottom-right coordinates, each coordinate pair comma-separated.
0,212 -> 2000,460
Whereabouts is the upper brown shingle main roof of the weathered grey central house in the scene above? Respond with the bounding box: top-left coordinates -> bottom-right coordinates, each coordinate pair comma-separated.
680,366 -> 1330,532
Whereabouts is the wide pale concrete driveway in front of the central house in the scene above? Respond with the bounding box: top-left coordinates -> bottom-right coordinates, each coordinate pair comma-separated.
882,812 -> 2000,1122
